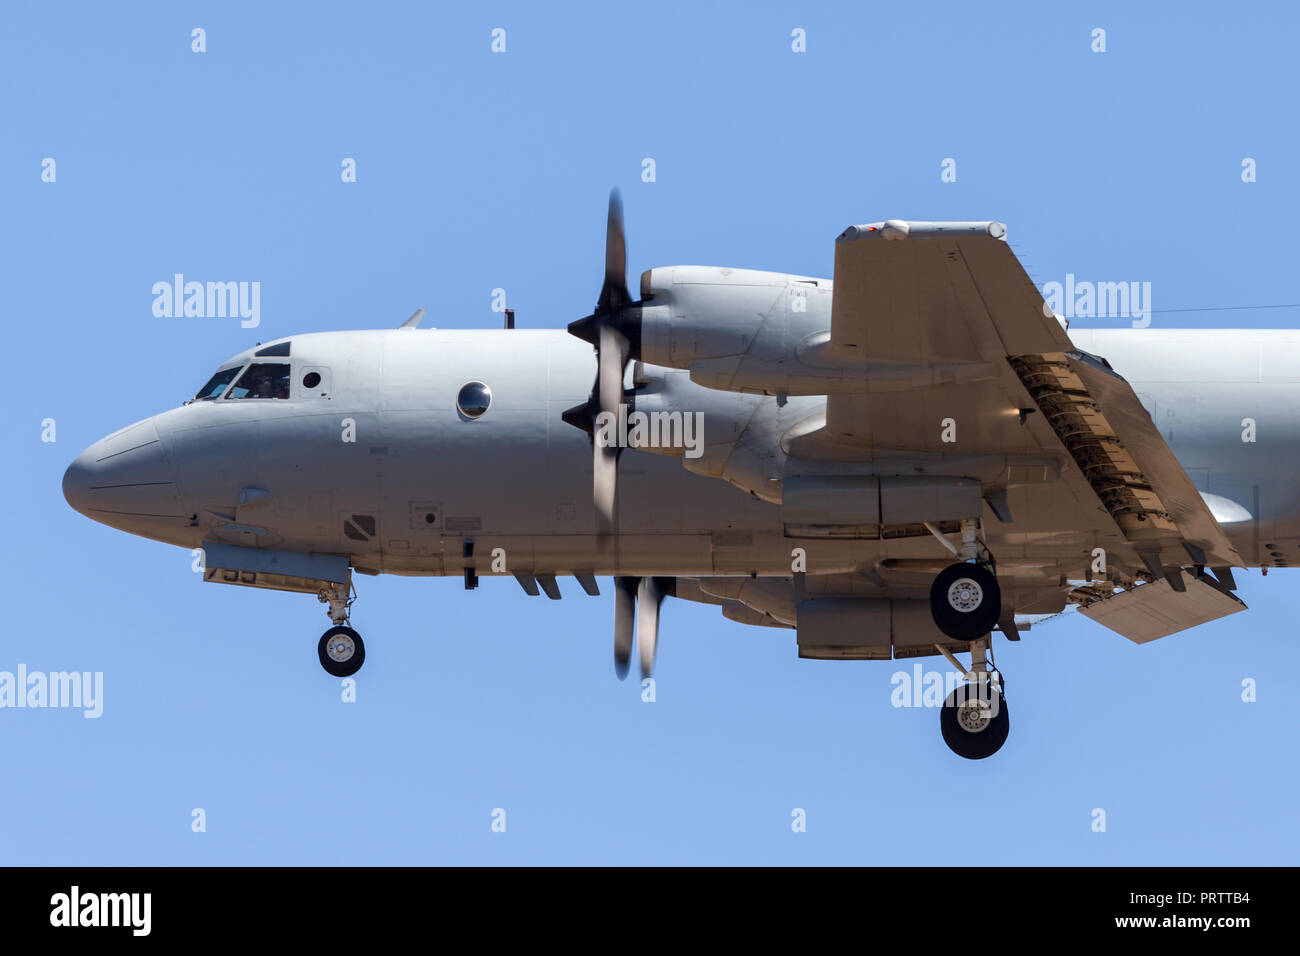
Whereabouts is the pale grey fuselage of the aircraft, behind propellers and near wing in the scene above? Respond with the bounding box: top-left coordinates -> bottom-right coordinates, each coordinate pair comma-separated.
65,329 -> 1300,576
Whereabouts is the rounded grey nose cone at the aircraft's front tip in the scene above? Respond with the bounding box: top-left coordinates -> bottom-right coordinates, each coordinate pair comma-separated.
64,419 -> 185,527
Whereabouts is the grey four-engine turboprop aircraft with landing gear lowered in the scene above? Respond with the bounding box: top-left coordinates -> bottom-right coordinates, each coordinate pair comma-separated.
64,193 -> 1274,758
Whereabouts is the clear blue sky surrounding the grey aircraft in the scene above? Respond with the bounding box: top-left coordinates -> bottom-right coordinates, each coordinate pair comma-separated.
0,3 -> 1300,864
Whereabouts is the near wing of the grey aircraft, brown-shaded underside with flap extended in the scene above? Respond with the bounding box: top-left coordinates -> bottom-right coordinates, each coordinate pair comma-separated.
816,220 -> 1243,582
